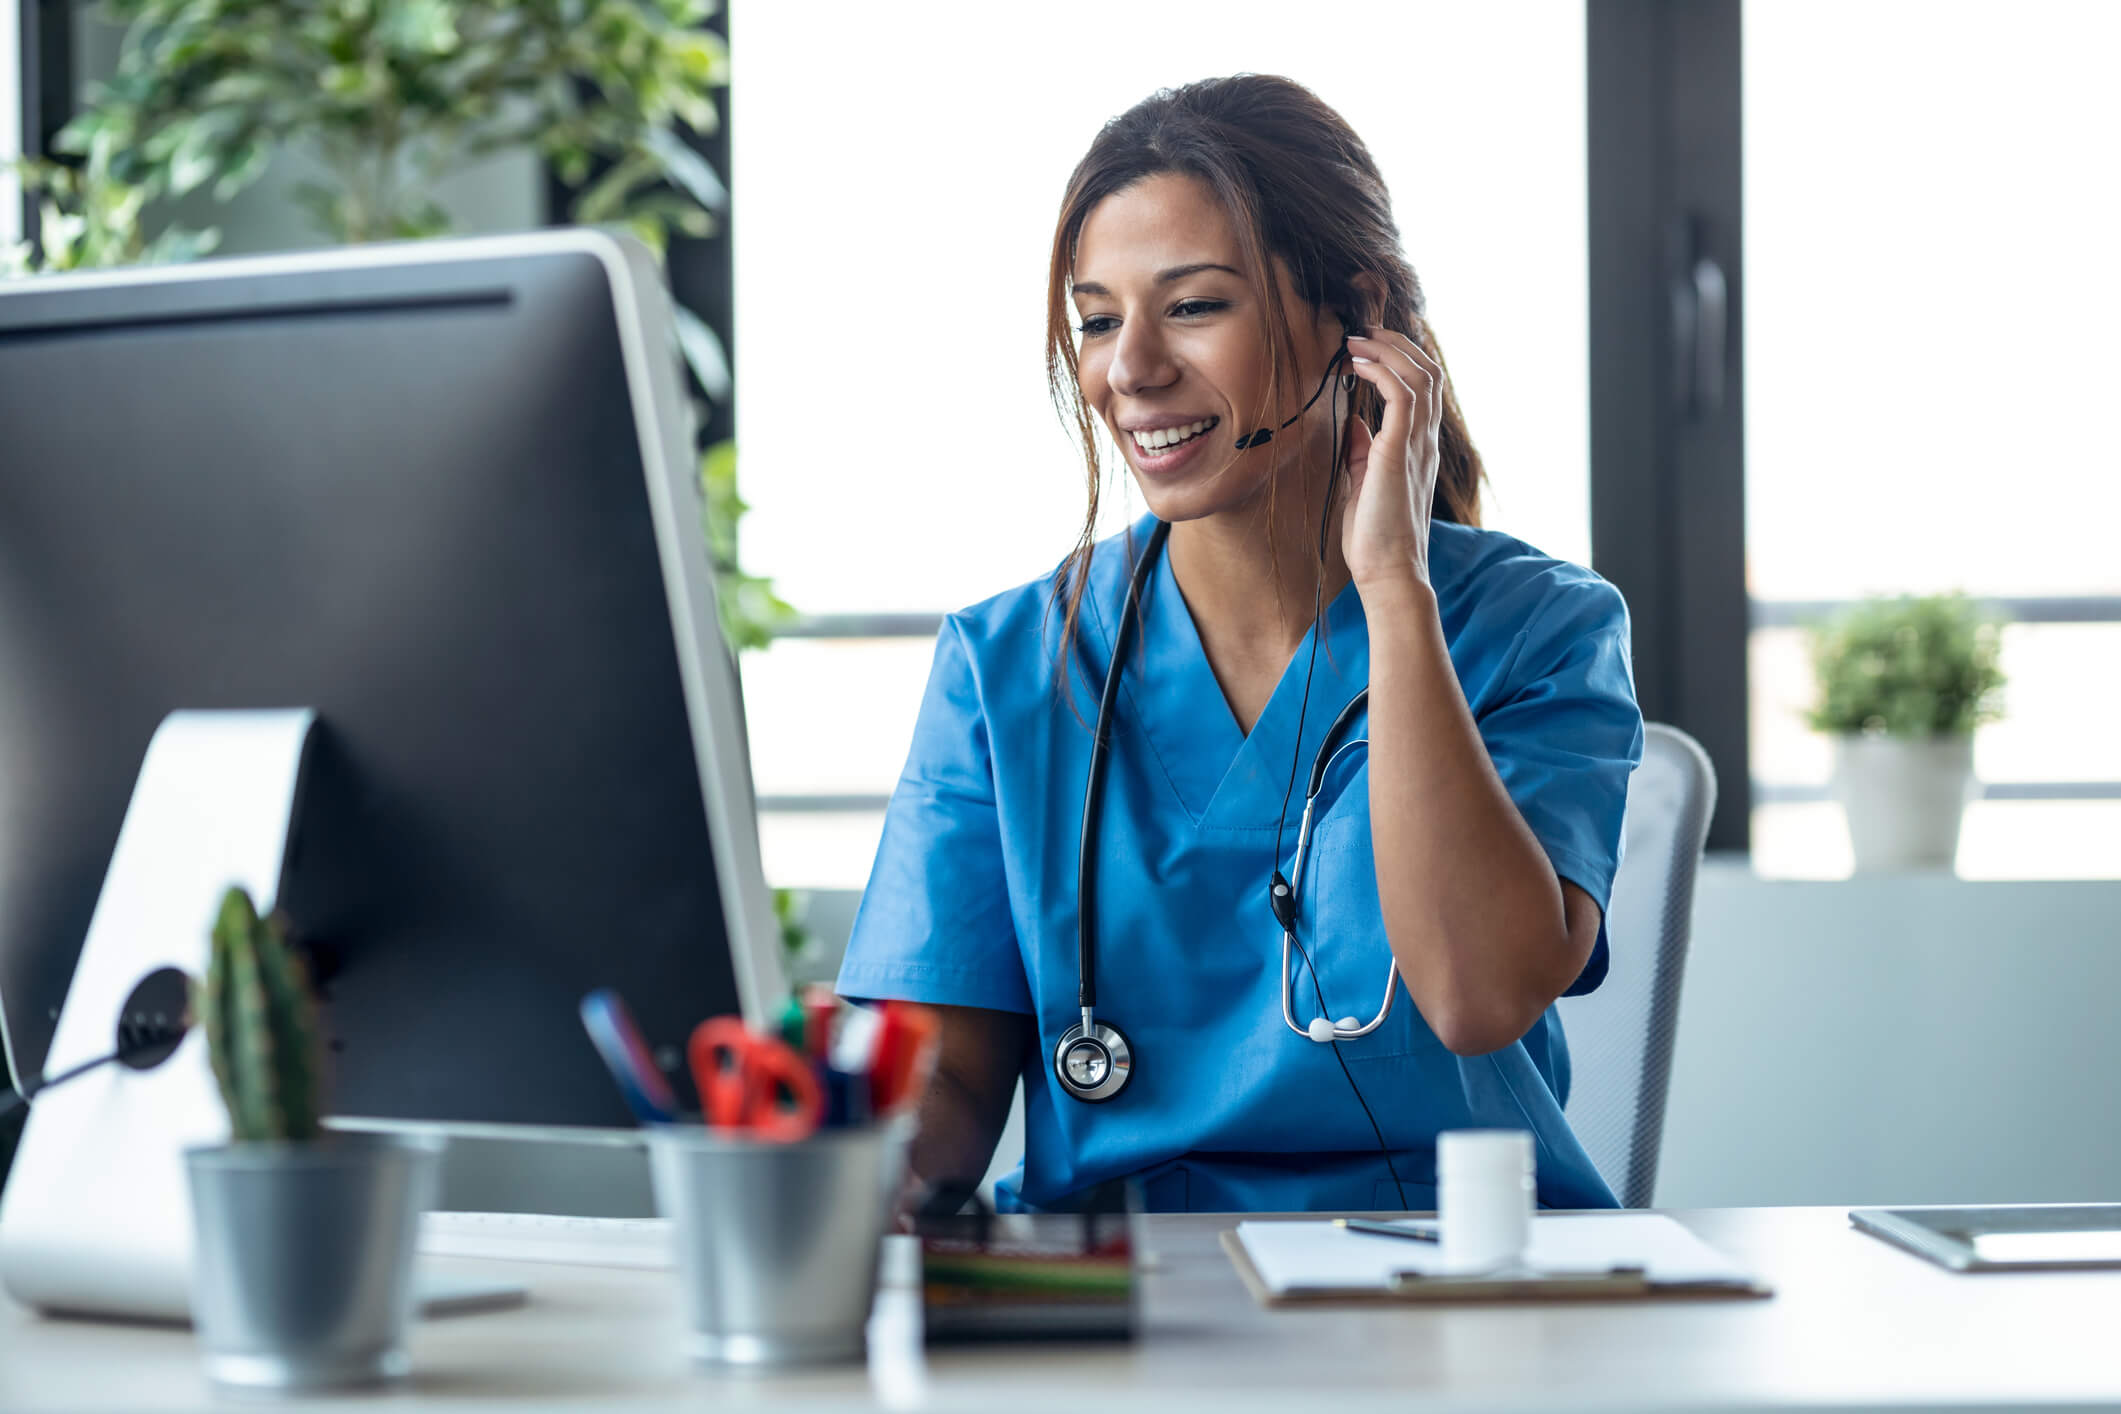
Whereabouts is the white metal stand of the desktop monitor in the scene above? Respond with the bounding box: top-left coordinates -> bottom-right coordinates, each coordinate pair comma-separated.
0,708 -> 522,1321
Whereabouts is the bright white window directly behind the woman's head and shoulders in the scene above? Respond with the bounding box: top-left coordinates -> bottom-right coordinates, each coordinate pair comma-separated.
732,0 -> 1591,888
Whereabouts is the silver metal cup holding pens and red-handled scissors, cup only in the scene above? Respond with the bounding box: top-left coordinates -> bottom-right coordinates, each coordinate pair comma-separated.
649,1117 -> 912,1365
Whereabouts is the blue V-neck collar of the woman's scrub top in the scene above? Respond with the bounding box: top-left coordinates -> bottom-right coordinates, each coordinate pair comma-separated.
1099,517 -> 1370,829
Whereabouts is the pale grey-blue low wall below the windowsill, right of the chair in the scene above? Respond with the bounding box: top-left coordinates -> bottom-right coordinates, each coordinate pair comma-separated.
810,863 -> 2121,1206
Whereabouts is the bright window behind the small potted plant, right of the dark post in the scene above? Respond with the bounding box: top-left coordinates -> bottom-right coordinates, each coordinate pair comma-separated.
1743,0 -> 2121,878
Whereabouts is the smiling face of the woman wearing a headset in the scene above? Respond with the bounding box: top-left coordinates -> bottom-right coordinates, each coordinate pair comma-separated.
1073,174 -> 1340,522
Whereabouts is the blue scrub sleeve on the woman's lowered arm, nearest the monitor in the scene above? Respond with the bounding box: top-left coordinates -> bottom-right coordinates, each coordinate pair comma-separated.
838,619 -> 1031,1011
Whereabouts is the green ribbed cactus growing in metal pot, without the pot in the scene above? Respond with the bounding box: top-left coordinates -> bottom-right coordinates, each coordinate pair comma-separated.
191,886 -> 322,1143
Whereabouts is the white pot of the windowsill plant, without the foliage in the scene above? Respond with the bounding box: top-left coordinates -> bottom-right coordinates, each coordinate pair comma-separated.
1833,733 -> 1977,873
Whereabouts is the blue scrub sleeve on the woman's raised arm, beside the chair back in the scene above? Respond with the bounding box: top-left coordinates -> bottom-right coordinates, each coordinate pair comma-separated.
1478,579 -> 1642,996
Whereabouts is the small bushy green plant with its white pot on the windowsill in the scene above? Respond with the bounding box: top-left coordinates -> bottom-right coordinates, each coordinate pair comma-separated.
1807,594 -> 2004,871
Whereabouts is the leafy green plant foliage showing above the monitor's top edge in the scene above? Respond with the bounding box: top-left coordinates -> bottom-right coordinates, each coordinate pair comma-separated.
55,0 -> 730,403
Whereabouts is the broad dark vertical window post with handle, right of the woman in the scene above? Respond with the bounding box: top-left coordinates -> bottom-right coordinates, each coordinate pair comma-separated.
1584,0 -> 1752,850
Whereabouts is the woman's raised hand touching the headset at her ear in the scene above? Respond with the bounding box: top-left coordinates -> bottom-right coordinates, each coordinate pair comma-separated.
1340,329 -> 1444,594
